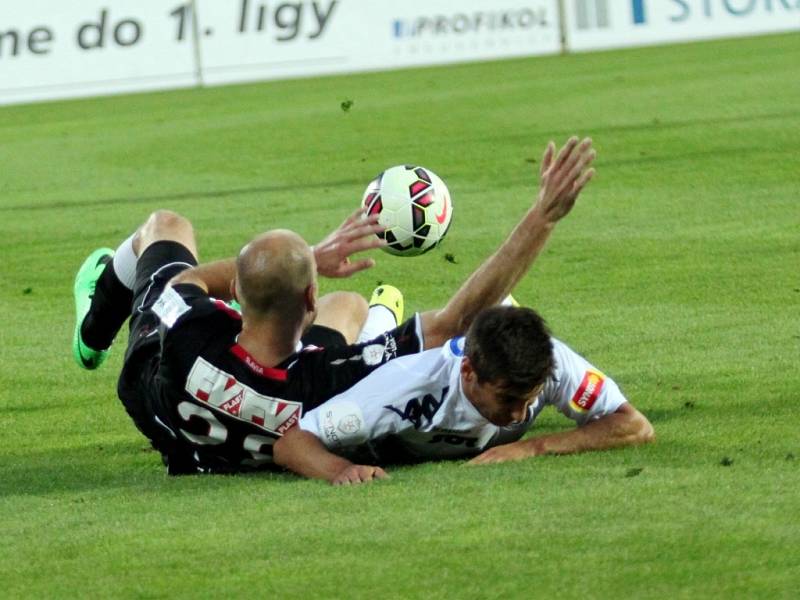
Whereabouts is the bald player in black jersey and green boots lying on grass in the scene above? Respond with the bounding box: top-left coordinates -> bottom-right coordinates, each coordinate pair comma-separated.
73,138 -> 594,479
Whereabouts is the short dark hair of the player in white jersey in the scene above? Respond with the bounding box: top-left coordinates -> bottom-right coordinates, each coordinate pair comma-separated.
464,306 -> 554,397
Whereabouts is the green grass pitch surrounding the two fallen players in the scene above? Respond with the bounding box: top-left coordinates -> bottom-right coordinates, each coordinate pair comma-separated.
0,34 -> 800,598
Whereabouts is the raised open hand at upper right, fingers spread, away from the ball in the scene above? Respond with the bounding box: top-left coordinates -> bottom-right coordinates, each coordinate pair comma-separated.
536,136 -> 597,223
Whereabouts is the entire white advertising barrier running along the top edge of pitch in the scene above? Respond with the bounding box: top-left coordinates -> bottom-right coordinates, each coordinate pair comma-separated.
0,0 -> 800,104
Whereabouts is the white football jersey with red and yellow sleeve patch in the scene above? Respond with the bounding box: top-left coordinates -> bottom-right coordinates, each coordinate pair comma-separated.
300,338 -> 626,460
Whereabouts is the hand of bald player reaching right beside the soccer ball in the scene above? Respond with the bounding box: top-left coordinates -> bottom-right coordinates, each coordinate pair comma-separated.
313,208 -> 386,277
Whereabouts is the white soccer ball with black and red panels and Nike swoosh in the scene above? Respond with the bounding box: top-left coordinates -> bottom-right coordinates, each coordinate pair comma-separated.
362,165 -> 453,256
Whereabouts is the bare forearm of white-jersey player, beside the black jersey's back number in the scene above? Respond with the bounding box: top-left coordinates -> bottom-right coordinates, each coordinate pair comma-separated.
272,427 -> 352,482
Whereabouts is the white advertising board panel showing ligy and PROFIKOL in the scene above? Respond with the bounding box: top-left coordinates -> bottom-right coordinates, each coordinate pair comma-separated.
197,0 -> 561,83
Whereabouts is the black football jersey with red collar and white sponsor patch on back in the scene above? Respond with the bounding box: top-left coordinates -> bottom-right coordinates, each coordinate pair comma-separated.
151,284 -> 422,472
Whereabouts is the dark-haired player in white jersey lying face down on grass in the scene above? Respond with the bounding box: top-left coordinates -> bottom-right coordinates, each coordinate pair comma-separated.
275,307 -> 653,483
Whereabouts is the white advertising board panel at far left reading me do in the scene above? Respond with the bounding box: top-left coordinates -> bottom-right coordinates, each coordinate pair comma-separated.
0,0 -> 197,103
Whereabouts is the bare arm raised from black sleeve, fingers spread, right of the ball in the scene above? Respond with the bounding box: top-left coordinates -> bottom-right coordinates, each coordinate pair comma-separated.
422,137 -> 595,348
